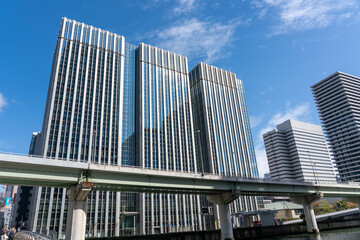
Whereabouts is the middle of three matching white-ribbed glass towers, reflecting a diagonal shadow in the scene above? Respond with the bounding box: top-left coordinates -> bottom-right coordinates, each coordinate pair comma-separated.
136,43 -> 201,234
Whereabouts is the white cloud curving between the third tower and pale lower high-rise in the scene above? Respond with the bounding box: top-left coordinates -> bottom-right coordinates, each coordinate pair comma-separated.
255,102 -> 310,177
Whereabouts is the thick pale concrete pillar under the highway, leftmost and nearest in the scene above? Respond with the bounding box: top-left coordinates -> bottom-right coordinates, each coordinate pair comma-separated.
66,182 -> 92,240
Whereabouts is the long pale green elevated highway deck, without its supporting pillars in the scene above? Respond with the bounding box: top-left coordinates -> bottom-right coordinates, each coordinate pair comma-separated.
0,153 -> 360,197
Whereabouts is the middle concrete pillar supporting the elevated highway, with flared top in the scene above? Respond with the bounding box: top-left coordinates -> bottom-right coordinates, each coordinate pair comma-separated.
206,192 -> 240,240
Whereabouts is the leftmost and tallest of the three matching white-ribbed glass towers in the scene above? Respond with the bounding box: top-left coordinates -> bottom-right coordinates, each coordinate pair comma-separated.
29,18 -> 131,238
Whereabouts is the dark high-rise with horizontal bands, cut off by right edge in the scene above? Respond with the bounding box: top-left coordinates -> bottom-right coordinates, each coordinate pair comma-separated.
311,72 -> 360,181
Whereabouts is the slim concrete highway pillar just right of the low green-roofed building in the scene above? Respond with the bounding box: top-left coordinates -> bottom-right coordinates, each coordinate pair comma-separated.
302,193 -> 323,233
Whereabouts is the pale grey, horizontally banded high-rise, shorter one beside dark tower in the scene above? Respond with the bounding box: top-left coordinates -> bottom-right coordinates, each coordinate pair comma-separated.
263,120 -> 336,182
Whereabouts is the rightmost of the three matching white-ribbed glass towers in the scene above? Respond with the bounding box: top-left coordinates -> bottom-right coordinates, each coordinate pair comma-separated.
189,63 -> 259,226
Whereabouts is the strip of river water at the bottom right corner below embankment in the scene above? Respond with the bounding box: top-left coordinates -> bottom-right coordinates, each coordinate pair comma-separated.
263,228 -> 360,240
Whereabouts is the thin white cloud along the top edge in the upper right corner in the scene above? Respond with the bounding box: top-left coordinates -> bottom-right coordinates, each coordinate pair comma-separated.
254,0 -> 359,35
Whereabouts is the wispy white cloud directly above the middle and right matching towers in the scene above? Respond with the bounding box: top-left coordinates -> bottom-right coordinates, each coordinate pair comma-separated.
150,18 -> 240,63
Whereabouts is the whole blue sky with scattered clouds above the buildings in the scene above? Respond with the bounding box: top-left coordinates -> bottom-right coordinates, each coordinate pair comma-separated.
0,0 -> 360,174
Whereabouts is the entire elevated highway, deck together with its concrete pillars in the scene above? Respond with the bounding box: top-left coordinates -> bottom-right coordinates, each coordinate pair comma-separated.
0,153 -> 360,239
